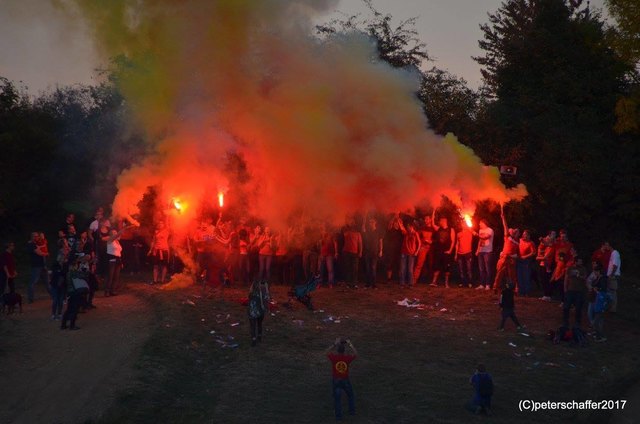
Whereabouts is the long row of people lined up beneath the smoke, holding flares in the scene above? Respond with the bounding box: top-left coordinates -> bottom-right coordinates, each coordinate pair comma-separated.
0,208 -> 620,339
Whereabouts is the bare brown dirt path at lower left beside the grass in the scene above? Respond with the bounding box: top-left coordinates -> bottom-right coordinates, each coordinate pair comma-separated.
0,292 -> 151,423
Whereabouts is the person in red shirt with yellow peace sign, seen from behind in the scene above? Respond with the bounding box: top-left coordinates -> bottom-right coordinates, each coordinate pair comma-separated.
327,338 -> 358,421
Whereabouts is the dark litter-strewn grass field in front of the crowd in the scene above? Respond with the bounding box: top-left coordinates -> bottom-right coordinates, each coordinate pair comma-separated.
101,280 -> 640,423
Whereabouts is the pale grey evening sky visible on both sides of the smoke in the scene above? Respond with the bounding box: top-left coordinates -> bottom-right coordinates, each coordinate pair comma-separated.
0,0 -> 603,94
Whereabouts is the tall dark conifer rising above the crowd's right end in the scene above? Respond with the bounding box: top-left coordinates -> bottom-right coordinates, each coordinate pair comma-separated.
473,0 -> 627,252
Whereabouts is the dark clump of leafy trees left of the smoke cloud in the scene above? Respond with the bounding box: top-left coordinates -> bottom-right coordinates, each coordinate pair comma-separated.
0,74 -> 145,236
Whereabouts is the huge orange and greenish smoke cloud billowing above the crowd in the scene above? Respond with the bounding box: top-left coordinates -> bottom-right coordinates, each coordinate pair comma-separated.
72,0 -> 526,232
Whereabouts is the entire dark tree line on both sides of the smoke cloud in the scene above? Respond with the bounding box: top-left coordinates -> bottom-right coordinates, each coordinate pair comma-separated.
0,0 -> 640,264
